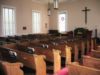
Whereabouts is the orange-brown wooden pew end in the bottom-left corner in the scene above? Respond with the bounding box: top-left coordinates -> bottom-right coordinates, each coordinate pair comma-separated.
0,61 -> 24,75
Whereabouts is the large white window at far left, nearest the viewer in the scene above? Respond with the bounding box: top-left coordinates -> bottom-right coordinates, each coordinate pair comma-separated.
2,6 -> 16,36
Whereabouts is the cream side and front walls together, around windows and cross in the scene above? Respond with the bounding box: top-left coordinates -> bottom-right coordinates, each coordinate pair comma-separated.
0,0 -> 100,36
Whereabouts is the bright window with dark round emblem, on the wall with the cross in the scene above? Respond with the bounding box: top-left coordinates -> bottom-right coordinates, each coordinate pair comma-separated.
58,12 -> 67,33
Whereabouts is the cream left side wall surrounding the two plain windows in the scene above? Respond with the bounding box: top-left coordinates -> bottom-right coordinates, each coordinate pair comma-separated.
0,0 -> 49,35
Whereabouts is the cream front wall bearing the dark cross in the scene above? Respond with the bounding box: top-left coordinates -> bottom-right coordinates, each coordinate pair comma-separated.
50,0 -> 100,36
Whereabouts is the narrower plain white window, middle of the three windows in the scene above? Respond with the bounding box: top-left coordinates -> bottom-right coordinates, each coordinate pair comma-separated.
32,11 -> 41,33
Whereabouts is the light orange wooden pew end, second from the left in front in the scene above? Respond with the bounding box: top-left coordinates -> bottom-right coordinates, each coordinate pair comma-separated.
34,55 -> 46,75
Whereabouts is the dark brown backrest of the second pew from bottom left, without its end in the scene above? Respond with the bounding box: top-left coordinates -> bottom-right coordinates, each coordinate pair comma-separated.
2,44 -> 35,69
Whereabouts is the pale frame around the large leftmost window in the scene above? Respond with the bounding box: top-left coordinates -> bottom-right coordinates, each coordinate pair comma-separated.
1,5 -> 17,36
